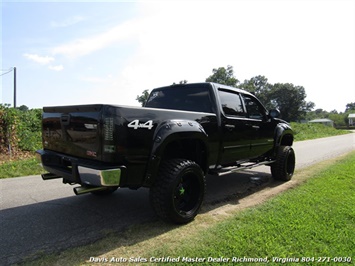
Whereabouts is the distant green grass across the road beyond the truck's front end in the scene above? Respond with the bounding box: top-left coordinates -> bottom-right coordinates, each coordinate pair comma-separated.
291,122 -> 349,141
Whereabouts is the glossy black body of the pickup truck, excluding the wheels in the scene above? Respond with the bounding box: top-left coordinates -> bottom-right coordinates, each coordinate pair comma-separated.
38,83 -> 293,188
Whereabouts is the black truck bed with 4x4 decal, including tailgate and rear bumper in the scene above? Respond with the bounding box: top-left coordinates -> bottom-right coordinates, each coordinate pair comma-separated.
38,98 -> 218,188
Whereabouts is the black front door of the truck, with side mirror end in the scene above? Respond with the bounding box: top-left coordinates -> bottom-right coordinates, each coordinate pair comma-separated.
241,93 -> 275,158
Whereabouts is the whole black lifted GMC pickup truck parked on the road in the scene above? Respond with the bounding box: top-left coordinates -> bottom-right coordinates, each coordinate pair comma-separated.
37,83 -> 295,224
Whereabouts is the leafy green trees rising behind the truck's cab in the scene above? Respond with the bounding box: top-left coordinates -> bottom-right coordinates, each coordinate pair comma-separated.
136,65 -> 355,126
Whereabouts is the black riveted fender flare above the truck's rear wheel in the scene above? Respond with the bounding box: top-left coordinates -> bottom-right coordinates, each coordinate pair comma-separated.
144,119 -> 209,187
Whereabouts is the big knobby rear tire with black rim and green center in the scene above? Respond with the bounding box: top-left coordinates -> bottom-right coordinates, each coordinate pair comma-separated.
149,159 -> 206,224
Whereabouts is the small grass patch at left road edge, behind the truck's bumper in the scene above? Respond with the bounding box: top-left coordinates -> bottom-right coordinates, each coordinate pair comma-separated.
0,158 -> 44,179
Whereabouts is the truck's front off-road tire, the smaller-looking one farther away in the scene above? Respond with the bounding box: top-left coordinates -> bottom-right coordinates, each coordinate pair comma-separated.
271,146 -> 296,181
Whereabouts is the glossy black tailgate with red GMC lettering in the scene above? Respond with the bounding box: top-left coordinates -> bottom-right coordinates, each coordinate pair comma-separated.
42,105 -> 103,159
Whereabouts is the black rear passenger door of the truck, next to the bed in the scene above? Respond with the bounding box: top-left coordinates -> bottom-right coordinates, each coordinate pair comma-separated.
218,89 -> 252,165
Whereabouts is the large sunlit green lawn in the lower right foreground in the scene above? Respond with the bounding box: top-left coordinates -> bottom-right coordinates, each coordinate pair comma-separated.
146,153 -> 355,265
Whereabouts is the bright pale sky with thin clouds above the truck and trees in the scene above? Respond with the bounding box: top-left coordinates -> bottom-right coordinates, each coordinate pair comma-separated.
0,0 -> 355,112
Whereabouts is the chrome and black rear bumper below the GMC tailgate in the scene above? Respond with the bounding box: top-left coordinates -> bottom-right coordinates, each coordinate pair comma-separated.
37,150 -> 126,187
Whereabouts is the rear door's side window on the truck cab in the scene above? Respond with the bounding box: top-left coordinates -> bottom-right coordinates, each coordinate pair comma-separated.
218,90 -> 246,117
